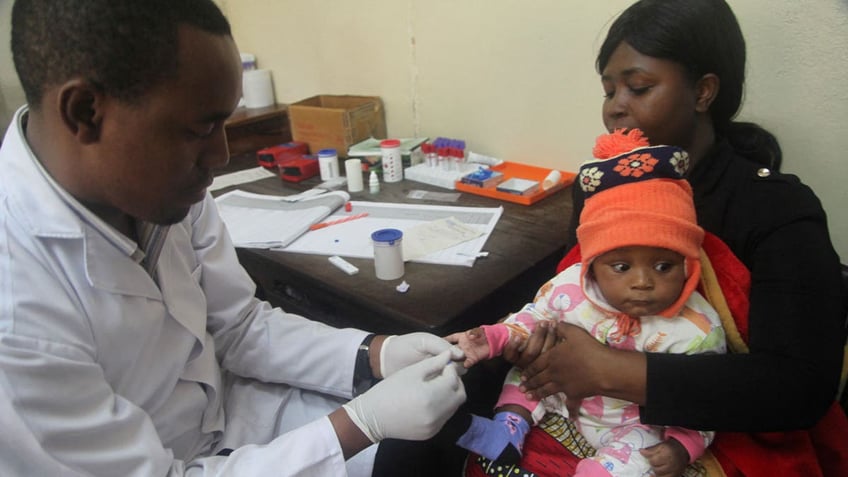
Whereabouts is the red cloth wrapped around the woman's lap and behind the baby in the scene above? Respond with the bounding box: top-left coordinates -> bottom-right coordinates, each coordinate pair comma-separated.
466,232 -> 848,477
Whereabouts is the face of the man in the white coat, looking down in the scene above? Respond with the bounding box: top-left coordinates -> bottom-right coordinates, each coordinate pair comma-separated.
93,26 -> 241,224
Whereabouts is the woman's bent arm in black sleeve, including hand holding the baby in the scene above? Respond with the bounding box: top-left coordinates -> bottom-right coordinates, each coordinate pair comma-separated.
524,217 -> 845,431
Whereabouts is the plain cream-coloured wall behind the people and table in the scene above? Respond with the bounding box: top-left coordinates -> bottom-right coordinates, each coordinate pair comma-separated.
0,0 -> 848,262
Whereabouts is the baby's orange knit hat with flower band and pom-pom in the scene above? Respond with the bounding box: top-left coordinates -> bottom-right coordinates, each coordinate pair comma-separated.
577,129 -> 704,315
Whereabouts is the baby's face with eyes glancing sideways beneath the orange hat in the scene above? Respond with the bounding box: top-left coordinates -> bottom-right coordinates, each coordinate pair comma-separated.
591,246 -> 686,316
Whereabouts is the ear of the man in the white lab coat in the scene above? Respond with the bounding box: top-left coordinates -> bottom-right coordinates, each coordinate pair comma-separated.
58,79 -> 104,144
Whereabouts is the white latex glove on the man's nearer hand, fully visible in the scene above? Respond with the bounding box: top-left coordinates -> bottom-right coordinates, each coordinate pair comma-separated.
343,350 -> 465,443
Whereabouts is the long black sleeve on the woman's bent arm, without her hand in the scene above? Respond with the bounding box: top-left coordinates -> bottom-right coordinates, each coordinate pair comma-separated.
642,216 -> 845,431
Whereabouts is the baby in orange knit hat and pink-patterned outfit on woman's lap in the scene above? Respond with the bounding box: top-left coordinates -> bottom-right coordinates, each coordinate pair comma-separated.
447,130 -> 726,476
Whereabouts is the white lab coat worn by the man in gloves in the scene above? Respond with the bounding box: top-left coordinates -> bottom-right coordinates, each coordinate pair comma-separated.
0,108 -> 373,476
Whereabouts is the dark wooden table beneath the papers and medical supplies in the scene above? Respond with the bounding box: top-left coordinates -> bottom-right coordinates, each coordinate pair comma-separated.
225,178 -> 571,335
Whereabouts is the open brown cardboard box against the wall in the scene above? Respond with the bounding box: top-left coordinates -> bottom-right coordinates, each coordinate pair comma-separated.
289,95 -> 386,157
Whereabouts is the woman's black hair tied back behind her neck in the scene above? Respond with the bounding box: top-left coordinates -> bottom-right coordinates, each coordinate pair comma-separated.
596,0 -> 782,170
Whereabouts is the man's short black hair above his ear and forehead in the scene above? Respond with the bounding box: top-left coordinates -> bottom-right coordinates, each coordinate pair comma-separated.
11,0 -> 231,108
